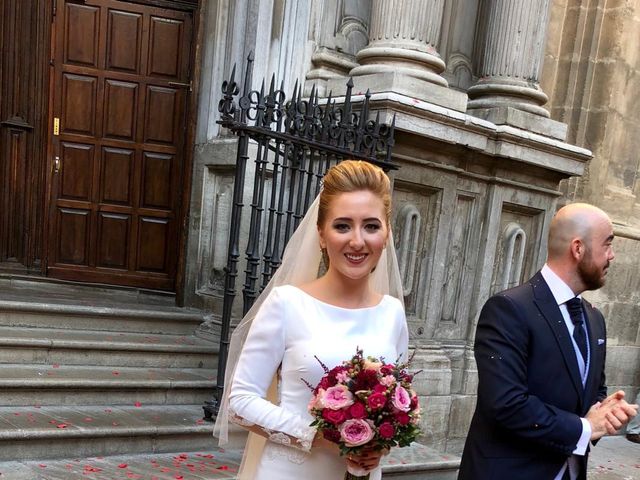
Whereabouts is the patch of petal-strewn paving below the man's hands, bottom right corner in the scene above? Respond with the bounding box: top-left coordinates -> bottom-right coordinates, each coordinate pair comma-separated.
588,436 -> 640,480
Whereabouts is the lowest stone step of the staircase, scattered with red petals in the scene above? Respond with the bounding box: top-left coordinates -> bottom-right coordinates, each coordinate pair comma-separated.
0,405 -> 214,464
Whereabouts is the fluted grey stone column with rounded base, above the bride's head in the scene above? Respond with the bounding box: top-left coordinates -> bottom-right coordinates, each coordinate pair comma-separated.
350,0 -> 447,87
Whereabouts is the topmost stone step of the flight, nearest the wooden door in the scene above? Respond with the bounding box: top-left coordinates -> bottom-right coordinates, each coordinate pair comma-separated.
0,295 -> 204,335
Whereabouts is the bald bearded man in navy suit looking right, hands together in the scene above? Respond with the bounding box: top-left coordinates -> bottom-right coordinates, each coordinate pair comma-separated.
458,203 -> 637,480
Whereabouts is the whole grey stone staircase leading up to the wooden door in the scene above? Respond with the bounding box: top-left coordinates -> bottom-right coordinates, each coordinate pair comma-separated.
0,280 -> 217,461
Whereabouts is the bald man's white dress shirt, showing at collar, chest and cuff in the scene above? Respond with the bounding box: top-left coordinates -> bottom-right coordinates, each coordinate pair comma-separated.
540,263 -> 591,480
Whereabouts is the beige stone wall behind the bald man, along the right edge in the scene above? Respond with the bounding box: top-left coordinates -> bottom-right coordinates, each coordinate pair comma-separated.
541,0 -> 640,399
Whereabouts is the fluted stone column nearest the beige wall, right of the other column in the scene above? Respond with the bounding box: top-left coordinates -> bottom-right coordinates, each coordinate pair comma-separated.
467,0 -> 551,119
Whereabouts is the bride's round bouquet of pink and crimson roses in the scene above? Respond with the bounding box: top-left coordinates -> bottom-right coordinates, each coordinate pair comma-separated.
307,349 -> 420,480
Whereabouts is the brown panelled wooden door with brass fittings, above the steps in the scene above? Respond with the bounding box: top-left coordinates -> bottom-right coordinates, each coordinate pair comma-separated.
48,0 -> 193,289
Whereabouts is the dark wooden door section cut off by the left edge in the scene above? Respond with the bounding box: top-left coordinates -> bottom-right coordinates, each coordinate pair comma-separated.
0,0 -> 51,274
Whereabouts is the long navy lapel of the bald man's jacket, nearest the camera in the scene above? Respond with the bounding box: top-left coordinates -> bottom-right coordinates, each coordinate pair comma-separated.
531,272 -> 593,400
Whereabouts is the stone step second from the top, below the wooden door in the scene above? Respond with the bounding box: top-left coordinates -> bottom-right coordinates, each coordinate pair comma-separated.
0,326 -> 218,369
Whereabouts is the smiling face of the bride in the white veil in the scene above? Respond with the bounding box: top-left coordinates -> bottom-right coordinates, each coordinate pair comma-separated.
318,190 -> 389,280
